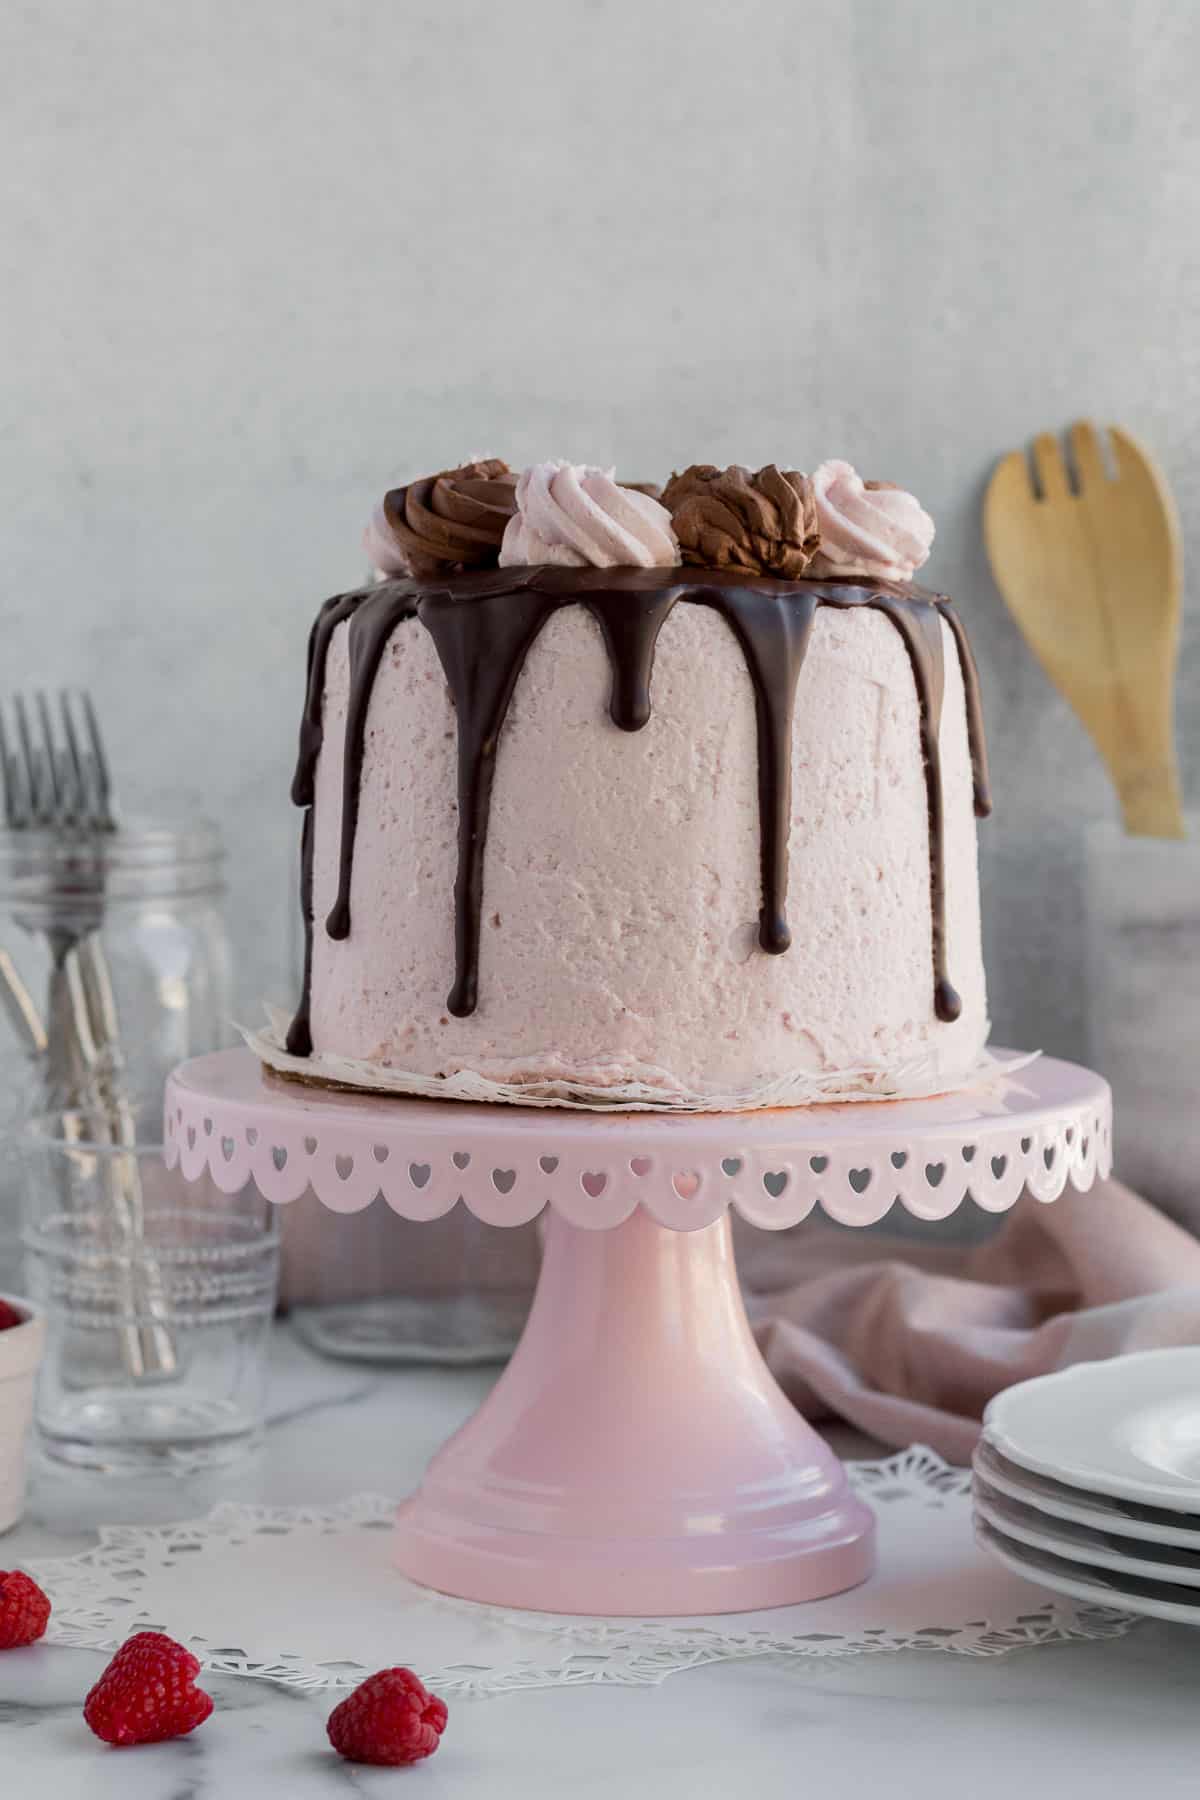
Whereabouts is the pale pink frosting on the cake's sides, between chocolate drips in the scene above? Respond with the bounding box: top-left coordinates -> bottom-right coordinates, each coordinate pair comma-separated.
311,597 -> 988,1103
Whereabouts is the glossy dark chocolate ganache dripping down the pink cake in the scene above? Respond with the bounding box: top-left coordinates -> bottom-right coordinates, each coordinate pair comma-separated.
288,565 -> 991,1057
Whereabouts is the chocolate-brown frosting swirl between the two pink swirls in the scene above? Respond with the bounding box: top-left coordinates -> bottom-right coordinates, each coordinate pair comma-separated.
662,463 -> 817,578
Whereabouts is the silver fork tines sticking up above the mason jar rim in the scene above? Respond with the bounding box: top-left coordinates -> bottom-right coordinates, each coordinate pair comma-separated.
0,688 -> 115,832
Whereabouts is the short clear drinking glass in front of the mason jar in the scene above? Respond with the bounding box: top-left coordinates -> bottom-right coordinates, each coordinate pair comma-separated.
20,1112 -> 279,1474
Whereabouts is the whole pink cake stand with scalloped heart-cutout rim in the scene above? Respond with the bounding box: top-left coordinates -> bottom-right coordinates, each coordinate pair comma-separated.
166,1049 -> 1112,1616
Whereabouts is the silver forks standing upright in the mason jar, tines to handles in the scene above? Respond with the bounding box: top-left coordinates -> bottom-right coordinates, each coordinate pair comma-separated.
0,691 -> 178,1379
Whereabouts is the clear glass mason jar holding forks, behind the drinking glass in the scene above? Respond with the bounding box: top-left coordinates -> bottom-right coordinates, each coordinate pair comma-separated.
0,819 -> 232,1111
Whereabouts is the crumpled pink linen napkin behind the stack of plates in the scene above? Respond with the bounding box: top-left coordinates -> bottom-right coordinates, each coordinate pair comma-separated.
738,1181 -> 1200,1463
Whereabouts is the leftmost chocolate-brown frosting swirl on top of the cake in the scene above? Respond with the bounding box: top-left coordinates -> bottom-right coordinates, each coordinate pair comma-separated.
363,457 -> 516,578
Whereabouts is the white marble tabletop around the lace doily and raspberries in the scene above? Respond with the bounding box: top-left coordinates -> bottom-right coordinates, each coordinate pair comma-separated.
0,1330 -> 1200,1800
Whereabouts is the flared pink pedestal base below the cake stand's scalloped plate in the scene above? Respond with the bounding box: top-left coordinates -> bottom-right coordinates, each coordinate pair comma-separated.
396,1211 -> 874,1615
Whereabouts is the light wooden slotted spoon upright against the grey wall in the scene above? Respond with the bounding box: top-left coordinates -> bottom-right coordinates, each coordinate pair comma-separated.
984,421 -> 1184,837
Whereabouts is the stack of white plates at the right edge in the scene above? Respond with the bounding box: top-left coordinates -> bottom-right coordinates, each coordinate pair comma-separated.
975,1346 -> 1200,1625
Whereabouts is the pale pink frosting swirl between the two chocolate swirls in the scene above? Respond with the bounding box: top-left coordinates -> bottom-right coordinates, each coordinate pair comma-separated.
500,463 -> 680,569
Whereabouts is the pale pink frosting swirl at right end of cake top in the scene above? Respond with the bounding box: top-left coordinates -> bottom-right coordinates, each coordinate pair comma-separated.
810,459 -> 934,581
